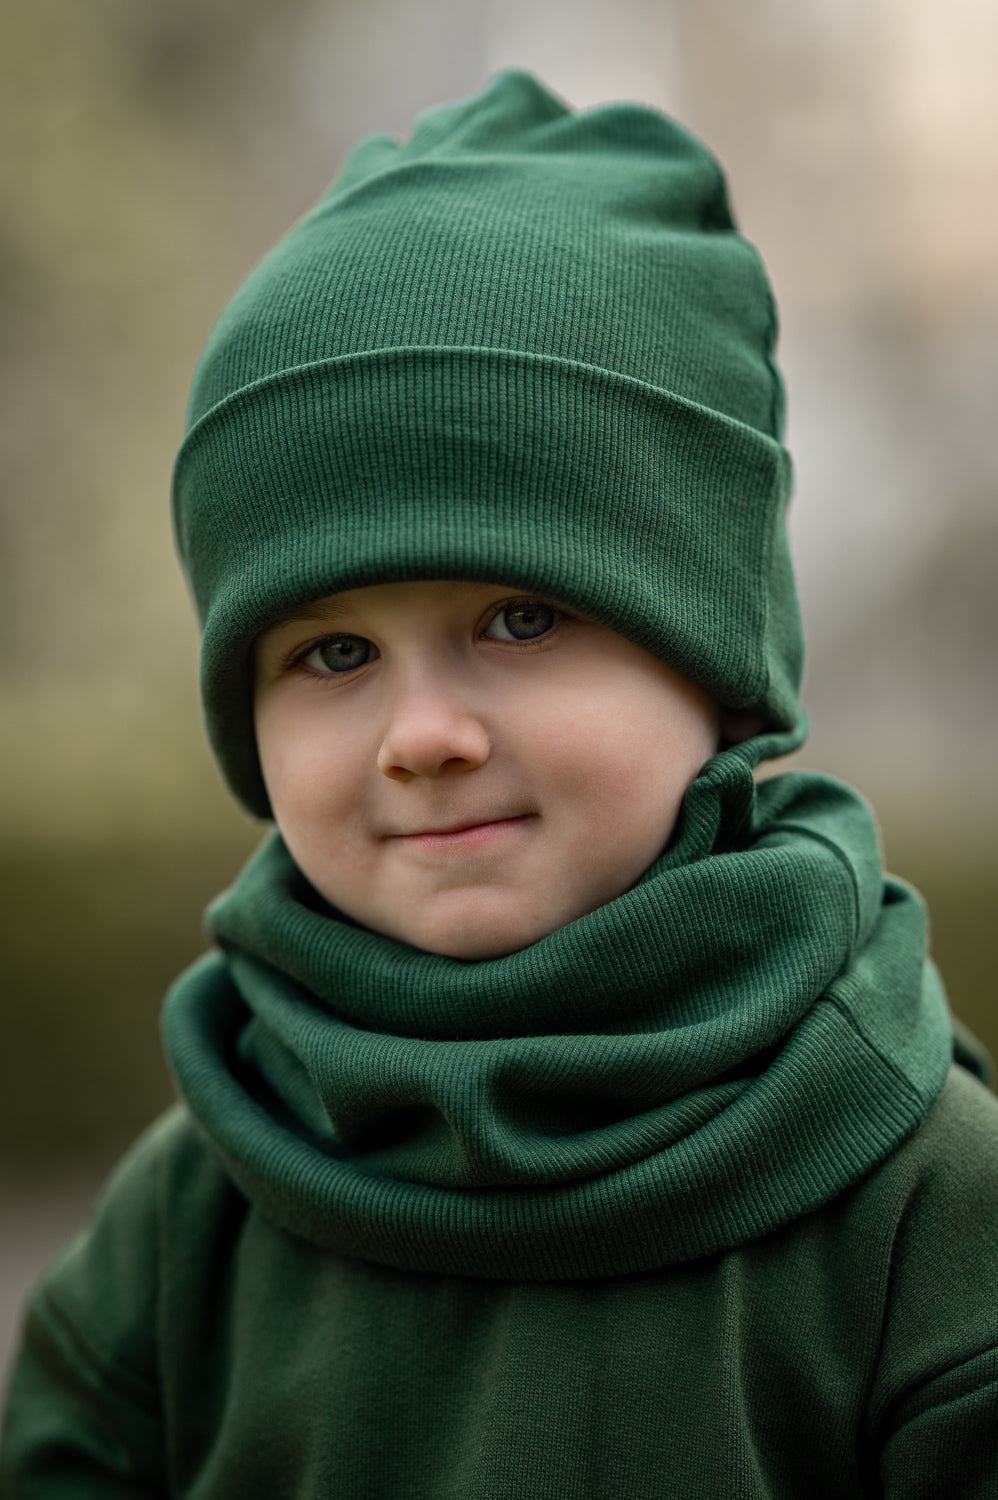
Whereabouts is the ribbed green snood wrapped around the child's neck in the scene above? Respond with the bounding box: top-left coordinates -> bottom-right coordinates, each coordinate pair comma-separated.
165,756 -> 951,1281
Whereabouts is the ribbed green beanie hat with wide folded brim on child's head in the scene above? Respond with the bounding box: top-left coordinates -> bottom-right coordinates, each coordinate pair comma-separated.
174,72 -> 806,816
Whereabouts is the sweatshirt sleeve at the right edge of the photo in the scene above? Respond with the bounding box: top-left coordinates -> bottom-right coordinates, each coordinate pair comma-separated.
872,1070 -> 998,1500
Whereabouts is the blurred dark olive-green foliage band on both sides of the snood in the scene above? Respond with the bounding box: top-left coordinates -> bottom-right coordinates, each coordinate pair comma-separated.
0,827 -> 998,1167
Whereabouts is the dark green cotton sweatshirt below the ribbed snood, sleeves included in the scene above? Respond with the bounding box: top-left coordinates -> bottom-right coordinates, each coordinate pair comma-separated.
0,1068 -> 998,1500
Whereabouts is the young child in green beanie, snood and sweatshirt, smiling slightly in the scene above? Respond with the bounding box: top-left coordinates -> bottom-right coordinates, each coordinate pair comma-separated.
3,74 -> 998,1500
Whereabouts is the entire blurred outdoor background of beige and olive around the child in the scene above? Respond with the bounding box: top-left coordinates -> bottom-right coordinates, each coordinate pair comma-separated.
0,0 -> 998,1380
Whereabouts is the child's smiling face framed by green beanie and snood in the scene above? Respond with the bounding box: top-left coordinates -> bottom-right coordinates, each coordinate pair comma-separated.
255,582 -> 719,959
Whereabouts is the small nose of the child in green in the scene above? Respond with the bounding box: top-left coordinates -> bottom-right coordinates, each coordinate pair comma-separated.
378,683 -> 492,782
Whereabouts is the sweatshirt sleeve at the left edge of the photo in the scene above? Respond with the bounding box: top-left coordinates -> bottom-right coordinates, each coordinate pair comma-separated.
0,1133 -> 167,1500
